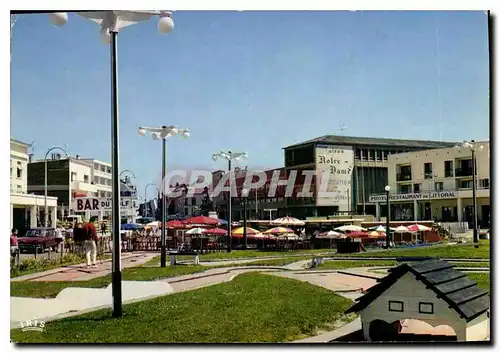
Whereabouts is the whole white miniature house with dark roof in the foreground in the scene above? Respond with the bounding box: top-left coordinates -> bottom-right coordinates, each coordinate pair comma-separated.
346,260 -> 490,341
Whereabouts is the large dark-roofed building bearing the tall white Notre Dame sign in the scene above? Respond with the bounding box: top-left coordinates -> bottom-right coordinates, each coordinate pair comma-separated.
284,135 -> 455,218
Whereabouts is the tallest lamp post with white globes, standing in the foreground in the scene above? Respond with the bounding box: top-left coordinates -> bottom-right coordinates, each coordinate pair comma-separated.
49,10 -> 174,317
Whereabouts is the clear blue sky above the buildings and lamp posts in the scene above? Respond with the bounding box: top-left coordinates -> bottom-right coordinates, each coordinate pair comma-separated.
11,11 -> 490,193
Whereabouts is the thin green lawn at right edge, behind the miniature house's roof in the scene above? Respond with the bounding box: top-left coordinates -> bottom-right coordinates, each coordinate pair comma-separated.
346,240 -> 490,259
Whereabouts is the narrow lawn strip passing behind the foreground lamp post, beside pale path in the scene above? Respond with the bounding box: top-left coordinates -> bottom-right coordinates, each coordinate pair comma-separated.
10,265 -> 208,298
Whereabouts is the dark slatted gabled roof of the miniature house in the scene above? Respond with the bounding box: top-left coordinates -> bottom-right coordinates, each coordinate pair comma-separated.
346,260 -> 490,322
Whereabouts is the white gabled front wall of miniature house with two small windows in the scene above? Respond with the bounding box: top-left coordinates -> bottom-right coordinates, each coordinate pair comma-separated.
360,272 -> 467,341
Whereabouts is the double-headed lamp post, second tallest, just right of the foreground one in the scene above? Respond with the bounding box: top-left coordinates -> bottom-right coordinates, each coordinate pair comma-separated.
139,125 -> 189,267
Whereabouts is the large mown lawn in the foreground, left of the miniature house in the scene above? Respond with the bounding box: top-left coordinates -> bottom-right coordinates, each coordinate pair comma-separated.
11,273 -> 354,343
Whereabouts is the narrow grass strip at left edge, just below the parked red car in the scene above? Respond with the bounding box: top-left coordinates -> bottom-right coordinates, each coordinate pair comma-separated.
10,254 -> 111,278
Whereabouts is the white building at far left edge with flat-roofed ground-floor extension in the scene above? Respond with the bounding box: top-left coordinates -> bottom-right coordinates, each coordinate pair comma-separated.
10,139 -> 57,234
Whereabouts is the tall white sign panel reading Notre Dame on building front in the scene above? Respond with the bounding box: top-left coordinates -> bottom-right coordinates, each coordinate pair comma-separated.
316,145 -> 354,211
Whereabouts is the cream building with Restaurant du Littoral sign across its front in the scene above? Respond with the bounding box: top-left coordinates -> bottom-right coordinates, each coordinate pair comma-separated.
370,141 -> 491,228
